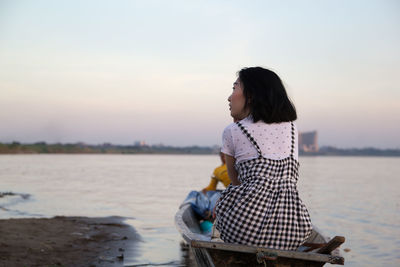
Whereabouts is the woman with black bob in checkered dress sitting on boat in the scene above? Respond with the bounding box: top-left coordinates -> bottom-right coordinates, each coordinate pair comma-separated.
215,67 -> 312,250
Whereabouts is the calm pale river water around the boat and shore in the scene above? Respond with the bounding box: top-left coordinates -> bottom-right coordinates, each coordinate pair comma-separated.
0,155 -> 400,266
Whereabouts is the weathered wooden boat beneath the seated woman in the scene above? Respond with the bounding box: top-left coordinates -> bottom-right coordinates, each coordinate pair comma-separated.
175,204 -> 344,267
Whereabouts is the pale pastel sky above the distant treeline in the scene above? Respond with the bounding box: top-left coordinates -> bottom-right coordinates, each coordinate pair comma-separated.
0,0 -> 400,148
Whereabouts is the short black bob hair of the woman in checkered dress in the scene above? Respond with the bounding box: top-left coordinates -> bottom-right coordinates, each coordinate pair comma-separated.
238,67 -> 297,123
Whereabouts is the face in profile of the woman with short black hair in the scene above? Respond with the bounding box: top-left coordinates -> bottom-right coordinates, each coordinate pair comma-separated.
228,78 -> 250,121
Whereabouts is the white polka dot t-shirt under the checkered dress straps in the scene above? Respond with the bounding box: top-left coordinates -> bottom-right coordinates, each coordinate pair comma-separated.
221,116 -> 299,163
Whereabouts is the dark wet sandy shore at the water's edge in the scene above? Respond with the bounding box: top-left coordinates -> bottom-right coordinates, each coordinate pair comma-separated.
0,217 -> 139,267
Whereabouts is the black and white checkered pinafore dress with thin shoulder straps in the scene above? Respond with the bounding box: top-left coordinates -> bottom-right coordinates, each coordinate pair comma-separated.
215,122 -> 312,250
